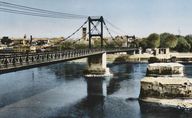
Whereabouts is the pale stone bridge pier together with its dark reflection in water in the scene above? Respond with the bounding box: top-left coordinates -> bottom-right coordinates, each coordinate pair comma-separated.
84,52 -> 112,96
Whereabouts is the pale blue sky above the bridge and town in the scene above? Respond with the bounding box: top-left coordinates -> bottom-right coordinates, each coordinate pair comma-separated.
0,0 -> 192,37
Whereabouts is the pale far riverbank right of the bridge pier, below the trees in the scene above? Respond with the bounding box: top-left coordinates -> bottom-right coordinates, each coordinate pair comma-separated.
107,52 -> 192,64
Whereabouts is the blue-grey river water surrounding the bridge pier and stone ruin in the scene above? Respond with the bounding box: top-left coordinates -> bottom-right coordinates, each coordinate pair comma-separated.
0,62 -> 192,118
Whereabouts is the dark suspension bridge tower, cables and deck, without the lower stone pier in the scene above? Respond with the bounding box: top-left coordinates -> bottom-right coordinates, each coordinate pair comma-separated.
0,1 -> 138,73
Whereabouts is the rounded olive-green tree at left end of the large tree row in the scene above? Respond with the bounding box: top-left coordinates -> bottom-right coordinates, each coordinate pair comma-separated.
147,33 -> 160,48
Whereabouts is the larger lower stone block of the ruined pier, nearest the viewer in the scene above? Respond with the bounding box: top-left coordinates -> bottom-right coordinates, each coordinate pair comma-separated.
139,77 -> 192,99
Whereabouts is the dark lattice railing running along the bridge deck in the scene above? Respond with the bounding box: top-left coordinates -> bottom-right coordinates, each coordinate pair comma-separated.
0,48 -> 135,70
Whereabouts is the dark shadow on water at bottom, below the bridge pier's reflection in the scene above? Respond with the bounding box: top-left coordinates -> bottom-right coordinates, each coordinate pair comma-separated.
55,96 -> 105,118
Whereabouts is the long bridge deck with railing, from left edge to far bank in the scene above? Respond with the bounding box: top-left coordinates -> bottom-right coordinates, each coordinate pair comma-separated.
0,48 -> 139,74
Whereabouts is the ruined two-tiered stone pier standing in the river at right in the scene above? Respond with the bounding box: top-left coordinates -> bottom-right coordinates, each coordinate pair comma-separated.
139,63 -> 192,109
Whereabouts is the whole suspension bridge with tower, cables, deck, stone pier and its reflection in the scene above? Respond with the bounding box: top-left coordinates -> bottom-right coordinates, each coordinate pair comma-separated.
0,1 -> 141,96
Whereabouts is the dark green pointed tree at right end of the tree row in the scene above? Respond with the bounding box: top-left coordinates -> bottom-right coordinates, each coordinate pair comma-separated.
175,36 -> 191,52
